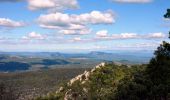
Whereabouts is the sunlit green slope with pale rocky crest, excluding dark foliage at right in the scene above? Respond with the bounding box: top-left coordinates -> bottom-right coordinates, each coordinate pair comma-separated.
34,63 -> 145,100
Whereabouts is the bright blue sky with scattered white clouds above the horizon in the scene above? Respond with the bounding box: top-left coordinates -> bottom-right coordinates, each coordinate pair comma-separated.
0,0 -> 170,52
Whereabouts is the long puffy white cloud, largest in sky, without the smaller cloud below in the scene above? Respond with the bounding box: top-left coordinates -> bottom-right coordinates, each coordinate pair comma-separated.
38,11 -> 115,29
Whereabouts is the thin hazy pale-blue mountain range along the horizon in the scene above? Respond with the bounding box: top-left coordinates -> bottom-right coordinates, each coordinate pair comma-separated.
0,51 -> 153,63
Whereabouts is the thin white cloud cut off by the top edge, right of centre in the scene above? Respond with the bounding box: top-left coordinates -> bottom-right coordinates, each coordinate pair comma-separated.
111,0 -> 153,3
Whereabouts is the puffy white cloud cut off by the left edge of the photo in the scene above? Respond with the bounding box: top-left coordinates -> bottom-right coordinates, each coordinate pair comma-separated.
0,18 -> 25,27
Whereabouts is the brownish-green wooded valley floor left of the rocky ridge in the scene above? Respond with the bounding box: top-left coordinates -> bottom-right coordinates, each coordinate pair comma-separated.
0,68 -> 89,100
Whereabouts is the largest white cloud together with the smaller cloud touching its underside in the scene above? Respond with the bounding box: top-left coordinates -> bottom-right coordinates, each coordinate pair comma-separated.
37,11 -> 115,35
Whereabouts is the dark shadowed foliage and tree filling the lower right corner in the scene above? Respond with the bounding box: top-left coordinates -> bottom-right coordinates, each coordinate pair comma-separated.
116,9 -> 170,100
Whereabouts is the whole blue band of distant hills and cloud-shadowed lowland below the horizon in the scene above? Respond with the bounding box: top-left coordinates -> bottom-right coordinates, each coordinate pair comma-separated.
0,51 -> 153,72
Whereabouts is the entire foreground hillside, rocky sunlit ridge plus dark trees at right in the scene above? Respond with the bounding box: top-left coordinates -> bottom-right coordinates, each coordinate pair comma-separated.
37,9 -> 170,100
